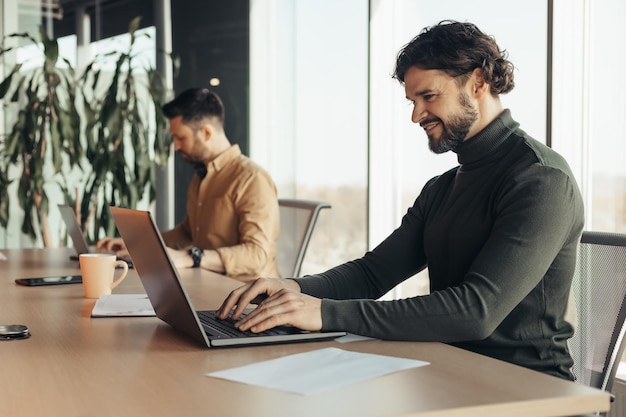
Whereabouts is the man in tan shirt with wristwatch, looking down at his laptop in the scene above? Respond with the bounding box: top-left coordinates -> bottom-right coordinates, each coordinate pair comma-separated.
97,89 -> 280,281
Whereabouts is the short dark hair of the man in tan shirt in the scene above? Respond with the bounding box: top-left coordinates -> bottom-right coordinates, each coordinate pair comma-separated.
163,88 -> 224,127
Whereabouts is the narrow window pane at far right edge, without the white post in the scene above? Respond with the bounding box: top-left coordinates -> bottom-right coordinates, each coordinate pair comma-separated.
588,0 -> 626,233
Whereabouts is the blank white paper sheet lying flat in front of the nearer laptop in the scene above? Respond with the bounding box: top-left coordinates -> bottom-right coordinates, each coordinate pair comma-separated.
206,348 -> 428,395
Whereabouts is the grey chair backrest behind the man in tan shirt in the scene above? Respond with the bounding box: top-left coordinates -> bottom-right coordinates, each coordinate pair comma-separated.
276,199 -> 330,278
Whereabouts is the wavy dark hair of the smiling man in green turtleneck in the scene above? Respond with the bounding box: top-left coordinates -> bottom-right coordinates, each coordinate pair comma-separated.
393,20 -> 515,95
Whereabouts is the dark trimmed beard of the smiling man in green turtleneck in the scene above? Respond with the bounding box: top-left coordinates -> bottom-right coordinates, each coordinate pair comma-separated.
428,91 -> 478,154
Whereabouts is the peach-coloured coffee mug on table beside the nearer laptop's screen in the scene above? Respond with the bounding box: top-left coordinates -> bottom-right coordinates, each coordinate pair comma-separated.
79,253 -> 128,298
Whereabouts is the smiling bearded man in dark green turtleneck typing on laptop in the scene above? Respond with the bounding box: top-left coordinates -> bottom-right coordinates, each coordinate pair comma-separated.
219,21 -> 584,379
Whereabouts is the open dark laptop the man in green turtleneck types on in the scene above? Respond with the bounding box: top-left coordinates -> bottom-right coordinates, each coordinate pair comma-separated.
110,207 -> 346,347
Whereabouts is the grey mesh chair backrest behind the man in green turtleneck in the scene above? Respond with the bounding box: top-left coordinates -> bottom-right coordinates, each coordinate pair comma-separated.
570,232 -> 626,391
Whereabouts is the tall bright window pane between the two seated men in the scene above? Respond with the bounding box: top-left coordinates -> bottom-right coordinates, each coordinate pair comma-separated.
250,0 -> 368,274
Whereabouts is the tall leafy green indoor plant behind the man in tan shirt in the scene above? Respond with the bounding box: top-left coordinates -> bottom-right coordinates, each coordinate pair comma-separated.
0,17 -> 177,246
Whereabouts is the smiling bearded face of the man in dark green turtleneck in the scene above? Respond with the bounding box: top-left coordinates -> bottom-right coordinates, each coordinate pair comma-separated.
404,67 -> 478,153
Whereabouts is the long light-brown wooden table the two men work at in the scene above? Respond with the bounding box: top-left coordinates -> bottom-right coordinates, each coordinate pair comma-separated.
0,249 -> 609,417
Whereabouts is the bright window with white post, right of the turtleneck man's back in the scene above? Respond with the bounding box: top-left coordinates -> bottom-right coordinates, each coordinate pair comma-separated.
553,0 -> 626,233
